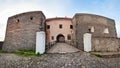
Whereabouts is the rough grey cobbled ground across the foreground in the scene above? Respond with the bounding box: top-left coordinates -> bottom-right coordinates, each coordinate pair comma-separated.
0,52 -> 120,68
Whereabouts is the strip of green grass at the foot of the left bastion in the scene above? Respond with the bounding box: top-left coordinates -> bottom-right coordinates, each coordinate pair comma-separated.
0,50 -> 42,57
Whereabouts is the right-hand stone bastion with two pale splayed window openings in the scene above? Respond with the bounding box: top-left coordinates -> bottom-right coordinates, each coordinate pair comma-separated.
73,13 -> 117,50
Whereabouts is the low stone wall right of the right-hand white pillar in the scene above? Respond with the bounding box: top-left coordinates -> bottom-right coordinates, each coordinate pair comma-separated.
91,37 -> 120,52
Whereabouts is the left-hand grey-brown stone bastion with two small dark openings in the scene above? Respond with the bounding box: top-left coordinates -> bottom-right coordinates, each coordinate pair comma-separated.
3,11 -> 46,52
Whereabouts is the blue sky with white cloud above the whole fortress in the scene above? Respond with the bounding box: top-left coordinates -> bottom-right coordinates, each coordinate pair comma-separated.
0,0 -> 120,40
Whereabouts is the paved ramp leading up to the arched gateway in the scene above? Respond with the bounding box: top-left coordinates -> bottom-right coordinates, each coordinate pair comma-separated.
47,43 -> 80,53
